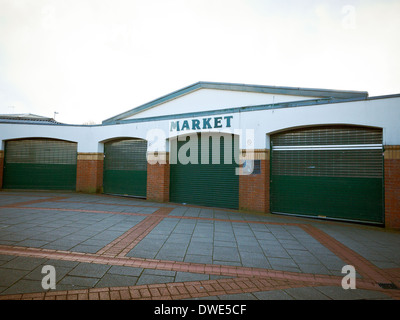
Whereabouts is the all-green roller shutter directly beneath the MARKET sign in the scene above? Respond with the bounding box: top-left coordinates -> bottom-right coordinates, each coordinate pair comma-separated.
170,134 -> 239,209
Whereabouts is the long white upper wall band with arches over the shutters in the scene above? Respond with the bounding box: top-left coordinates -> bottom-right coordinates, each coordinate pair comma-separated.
0,98 -> 400,152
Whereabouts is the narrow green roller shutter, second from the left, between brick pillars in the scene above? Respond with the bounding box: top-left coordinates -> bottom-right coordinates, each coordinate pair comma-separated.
103,139 -> 147,197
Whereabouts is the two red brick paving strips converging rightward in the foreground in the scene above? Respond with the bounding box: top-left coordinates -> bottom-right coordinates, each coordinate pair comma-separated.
0,245 -> 400,300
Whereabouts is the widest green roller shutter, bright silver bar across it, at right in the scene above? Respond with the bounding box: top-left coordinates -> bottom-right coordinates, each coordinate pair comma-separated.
271,126 -> 384,224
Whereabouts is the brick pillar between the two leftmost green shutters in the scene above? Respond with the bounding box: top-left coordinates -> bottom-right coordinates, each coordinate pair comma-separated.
76,153 -> 104,193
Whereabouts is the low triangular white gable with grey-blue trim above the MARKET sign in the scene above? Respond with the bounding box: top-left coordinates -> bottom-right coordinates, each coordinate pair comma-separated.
103,82 -> 368,124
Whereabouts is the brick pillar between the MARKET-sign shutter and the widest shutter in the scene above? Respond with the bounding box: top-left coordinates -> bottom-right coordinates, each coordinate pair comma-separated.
239,150 -> 269,212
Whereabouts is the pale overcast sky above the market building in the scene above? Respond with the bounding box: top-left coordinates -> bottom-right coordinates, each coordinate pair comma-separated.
0,0 -> 400,124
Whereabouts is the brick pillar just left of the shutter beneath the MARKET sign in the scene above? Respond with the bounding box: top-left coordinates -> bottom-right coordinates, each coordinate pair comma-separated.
146,152 -> 170,202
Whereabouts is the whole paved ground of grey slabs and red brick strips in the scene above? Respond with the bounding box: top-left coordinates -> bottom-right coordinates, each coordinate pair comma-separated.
0,191 -> 400,300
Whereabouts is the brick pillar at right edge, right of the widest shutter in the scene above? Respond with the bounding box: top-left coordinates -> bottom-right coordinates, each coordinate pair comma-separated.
384,146 -> 400,229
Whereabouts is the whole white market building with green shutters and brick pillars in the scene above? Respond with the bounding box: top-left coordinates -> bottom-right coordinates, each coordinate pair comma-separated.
0,82 -> 400,229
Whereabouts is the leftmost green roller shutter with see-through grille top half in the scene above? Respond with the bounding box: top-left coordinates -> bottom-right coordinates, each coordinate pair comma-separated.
3,139 -> 77,190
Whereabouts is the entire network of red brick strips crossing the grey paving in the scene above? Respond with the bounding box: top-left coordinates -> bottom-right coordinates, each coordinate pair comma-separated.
0,197 -> 400,300
